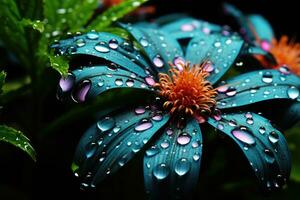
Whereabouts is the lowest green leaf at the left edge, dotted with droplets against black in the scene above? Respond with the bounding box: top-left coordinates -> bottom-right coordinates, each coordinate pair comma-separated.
0,125 -> 36,161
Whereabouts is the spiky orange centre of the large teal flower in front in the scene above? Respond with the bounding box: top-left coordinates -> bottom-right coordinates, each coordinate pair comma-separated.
156,63 -> 217,115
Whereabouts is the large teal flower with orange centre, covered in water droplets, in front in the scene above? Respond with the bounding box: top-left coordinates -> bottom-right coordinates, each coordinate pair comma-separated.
52,18 -> 300,199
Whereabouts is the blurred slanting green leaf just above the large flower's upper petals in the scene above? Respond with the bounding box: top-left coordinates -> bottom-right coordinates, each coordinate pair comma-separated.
87,0 -> 148,31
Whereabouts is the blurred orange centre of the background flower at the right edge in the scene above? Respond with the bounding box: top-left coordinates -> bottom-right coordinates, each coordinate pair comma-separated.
257,36 -> 300,75
